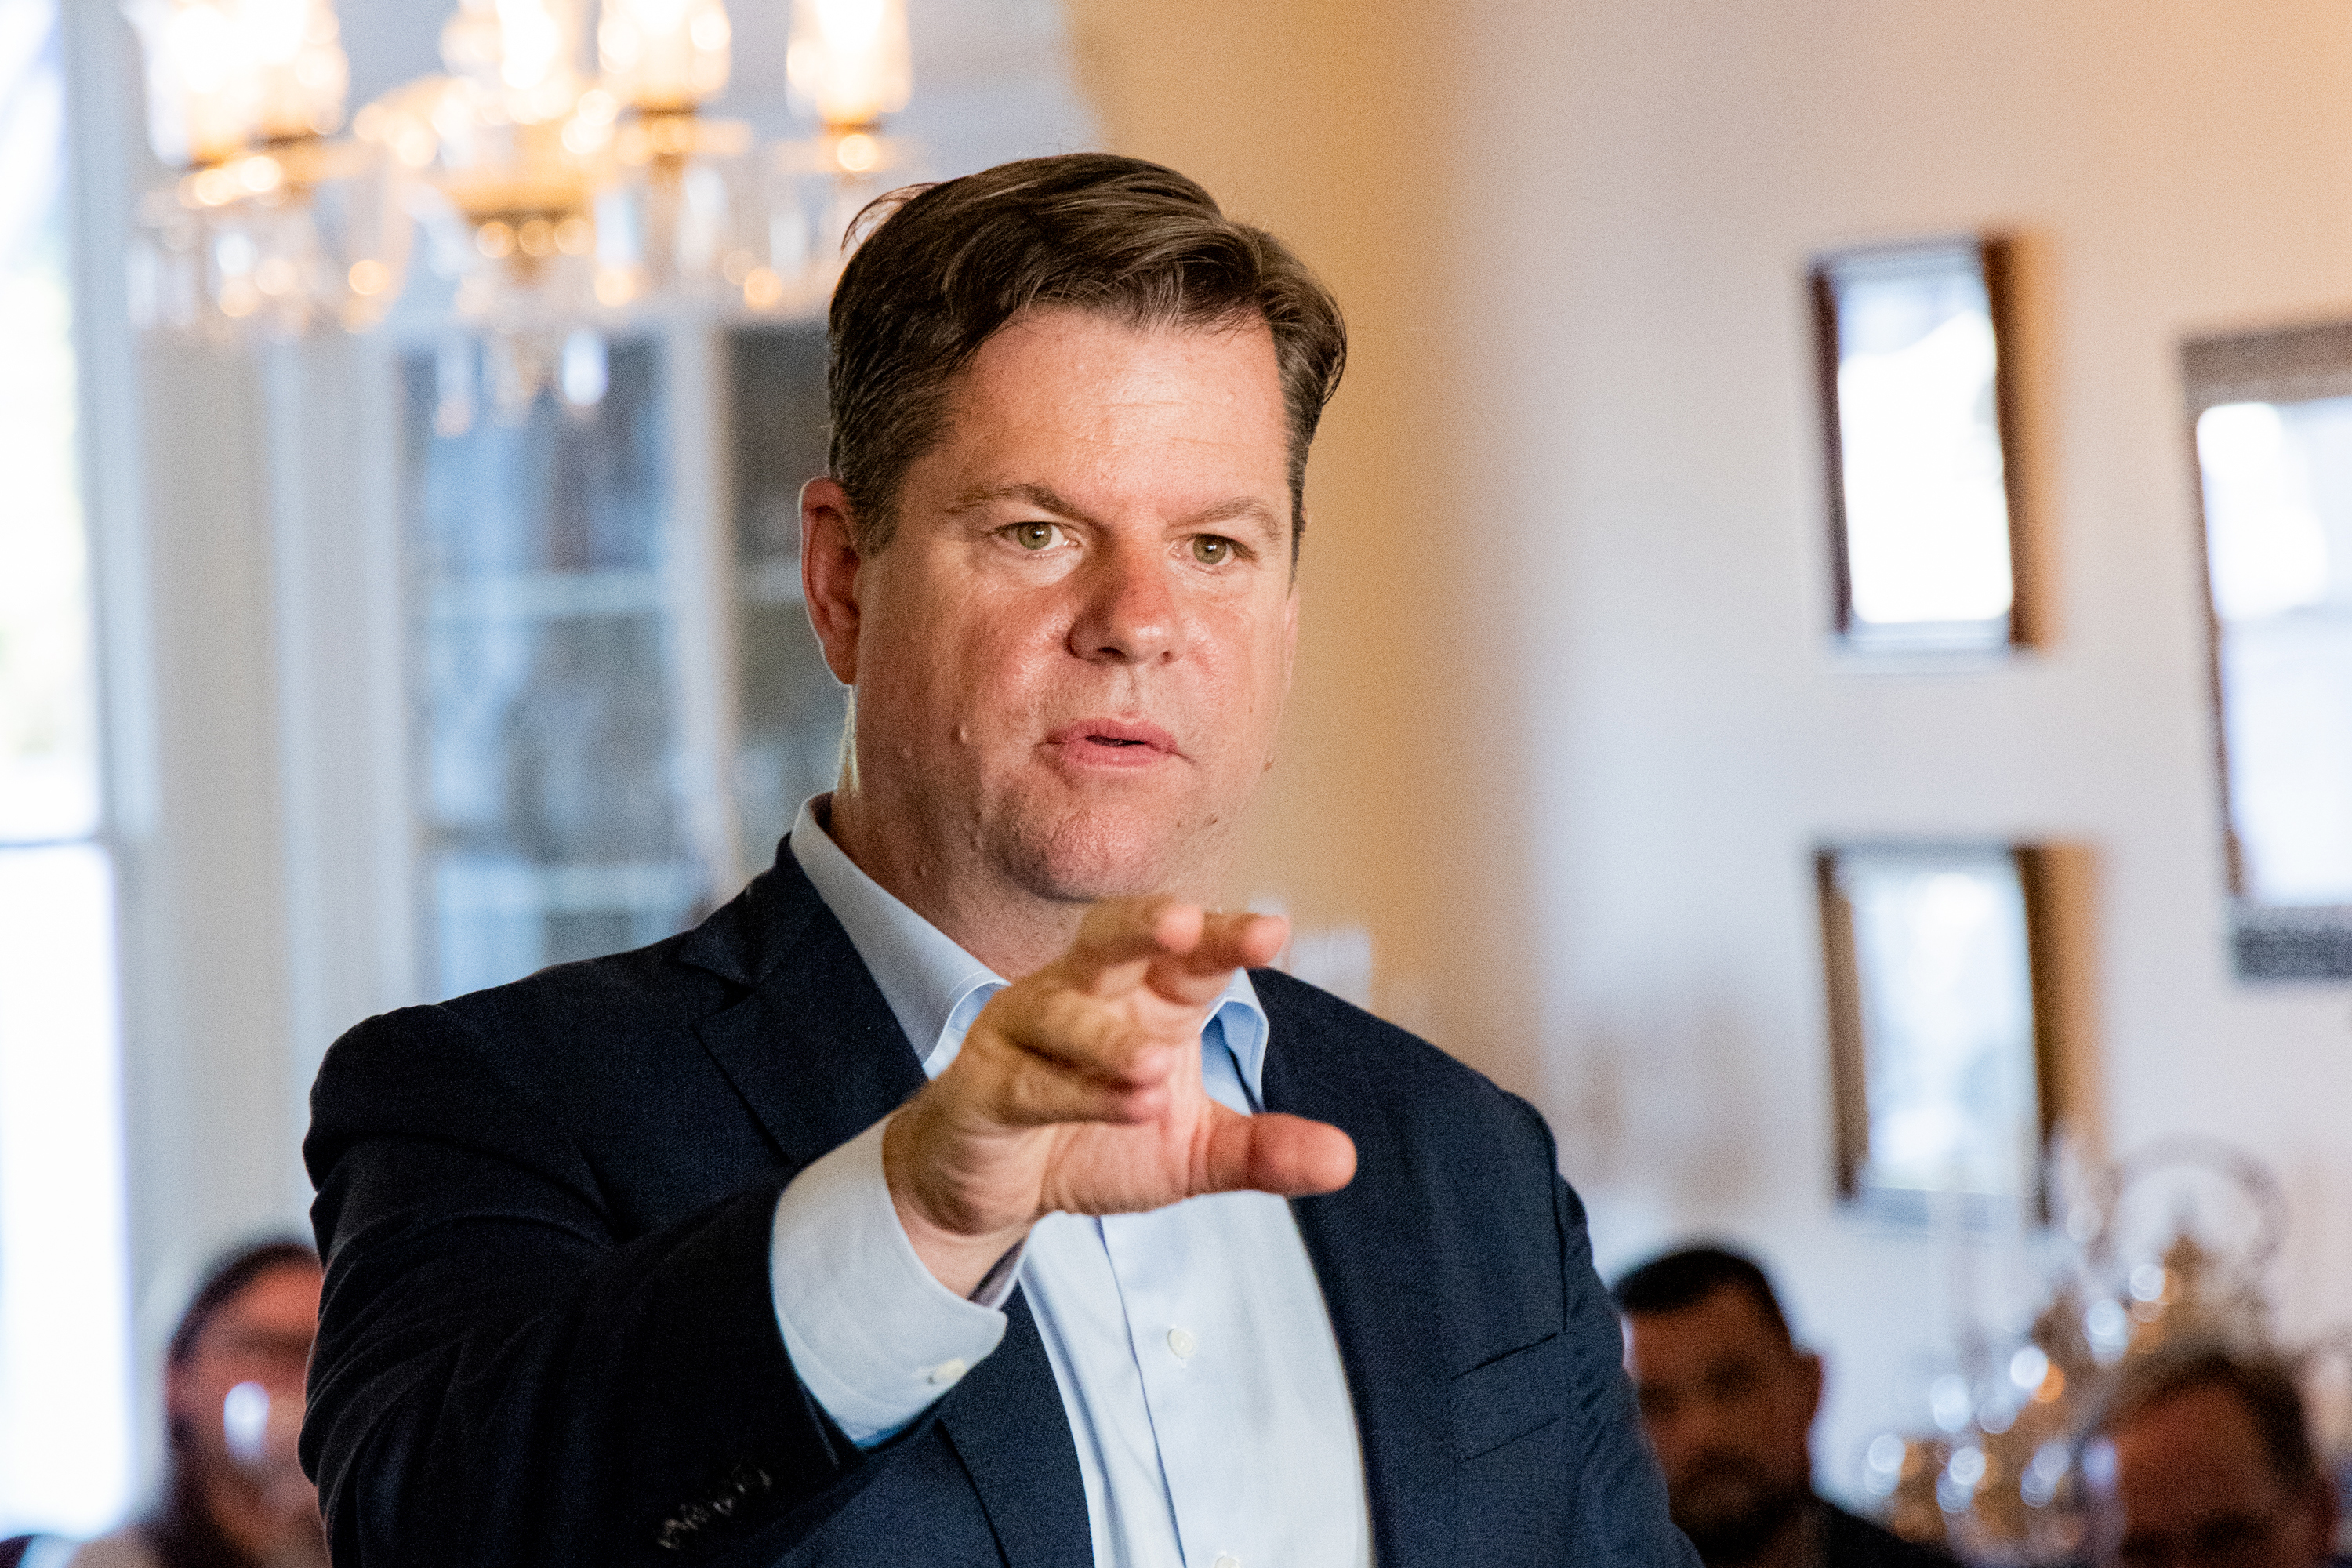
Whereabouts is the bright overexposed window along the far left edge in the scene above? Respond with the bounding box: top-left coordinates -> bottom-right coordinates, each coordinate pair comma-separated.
0,0 -> 132,1535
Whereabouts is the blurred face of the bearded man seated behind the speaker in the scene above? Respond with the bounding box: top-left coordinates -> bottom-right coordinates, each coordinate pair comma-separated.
1625,1286 -> 1820,1561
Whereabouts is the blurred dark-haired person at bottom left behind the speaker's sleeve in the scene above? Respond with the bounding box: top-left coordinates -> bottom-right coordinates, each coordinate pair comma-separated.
68,1241 -> 327,1568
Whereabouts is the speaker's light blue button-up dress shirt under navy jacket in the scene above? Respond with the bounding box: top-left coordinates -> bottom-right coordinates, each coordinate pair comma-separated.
769,797 -> 1371,1568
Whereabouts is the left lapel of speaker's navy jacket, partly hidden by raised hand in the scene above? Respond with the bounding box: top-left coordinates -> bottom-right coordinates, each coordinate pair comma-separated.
680,848 -> 1094,1568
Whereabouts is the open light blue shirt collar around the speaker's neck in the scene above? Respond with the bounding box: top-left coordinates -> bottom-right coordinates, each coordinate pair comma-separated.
790,794 -> 1268,1105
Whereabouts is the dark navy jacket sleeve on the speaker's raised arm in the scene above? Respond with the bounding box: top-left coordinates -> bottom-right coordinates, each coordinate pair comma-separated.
301,1008 -> 887,1568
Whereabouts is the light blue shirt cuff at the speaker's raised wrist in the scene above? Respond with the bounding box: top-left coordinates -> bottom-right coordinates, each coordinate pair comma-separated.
767,1121 -> 1021,1448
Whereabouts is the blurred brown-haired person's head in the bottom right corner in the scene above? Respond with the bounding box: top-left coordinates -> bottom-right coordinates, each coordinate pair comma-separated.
2082,1342 -> 2336,1568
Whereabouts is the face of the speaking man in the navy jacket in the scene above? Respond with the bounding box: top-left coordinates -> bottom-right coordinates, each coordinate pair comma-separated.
809,310 -> 1296,900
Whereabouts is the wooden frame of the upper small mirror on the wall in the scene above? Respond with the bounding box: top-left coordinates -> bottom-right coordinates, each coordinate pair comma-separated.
1806,235 -> 2037,654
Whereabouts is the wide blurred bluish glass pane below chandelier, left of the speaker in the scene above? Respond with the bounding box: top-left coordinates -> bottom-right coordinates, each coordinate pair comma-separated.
405,334 -> 715,996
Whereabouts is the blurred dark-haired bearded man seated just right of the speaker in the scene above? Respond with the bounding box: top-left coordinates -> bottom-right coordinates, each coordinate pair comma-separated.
1611,1246 -> 1955,1568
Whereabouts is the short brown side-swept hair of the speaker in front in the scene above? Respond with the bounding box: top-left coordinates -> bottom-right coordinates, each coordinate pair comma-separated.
828,153 -> 1348,560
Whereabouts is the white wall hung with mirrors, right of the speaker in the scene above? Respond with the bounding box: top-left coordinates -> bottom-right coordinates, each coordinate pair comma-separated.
1472,2 -> 2352,1474
